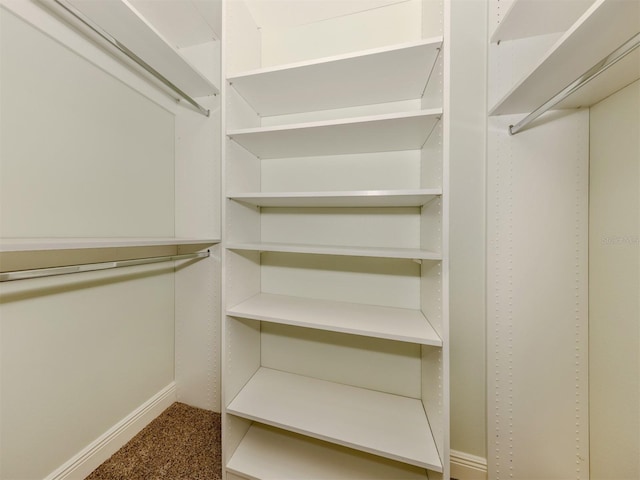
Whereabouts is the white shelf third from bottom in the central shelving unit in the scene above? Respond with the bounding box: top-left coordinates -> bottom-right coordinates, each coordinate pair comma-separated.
227,293 -> 442,347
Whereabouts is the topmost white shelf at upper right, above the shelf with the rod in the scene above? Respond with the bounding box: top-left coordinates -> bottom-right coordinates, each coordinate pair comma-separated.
491,0 -> 594,43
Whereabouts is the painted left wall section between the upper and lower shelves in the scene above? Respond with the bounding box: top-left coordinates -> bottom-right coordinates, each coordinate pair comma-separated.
0,9 -> 174,237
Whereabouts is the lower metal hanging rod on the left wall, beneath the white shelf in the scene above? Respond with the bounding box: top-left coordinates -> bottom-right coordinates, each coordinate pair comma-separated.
0,250 -> 210,282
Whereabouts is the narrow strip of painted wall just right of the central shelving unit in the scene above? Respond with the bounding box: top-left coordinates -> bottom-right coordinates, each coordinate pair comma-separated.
449,0 -> 487,458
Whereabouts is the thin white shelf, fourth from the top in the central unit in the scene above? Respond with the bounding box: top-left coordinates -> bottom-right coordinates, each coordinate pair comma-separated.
227,242 -> 442,260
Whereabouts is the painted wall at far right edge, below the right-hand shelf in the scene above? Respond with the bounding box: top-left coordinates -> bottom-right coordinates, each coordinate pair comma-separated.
589,81 -> 640,480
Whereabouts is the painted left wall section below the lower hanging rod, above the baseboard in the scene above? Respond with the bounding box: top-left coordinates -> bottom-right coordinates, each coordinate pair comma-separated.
0,265 -> 174,479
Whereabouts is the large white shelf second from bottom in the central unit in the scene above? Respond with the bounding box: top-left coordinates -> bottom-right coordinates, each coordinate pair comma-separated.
227,368 -> 442,472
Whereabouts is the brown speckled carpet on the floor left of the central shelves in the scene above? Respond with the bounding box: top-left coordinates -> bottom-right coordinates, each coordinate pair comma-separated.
86,403 -> 222,480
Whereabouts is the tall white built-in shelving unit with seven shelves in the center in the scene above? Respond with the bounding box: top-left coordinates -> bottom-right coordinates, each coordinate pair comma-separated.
222,1 -> 449,479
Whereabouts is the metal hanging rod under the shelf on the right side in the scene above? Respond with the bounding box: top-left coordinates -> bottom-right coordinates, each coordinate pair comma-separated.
509,33 -> 640,135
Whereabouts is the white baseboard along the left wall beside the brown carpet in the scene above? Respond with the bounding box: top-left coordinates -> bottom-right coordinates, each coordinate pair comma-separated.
45,382 -> 177,480
